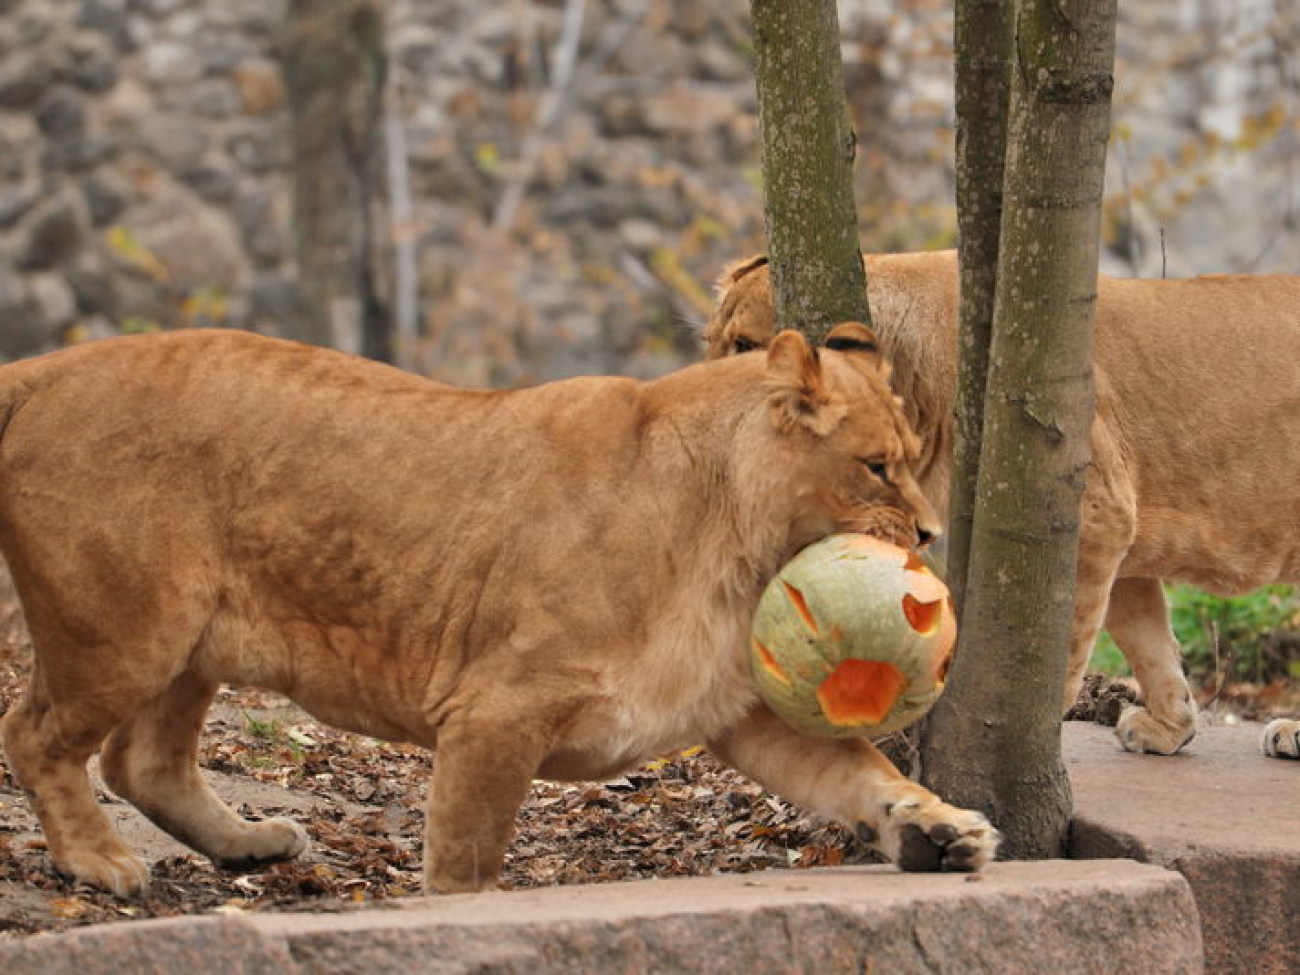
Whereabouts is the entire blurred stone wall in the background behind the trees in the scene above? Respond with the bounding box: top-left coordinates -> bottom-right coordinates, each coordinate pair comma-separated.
0,0 -> 1300,384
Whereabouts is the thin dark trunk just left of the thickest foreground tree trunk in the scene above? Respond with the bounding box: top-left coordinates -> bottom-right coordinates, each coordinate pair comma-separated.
946,0 -> 1015,619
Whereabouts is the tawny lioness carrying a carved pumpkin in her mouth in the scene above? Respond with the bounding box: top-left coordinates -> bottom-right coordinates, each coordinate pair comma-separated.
0,324 -> 998,894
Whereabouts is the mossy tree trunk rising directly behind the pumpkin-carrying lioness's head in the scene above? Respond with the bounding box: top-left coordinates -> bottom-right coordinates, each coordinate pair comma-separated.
751,0 -> 871,342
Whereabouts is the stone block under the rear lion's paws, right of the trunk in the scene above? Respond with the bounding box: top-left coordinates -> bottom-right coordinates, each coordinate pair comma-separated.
1062,723 -> 1300,975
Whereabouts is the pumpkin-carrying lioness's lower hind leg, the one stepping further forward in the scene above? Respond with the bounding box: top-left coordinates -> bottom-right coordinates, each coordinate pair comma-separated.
100,671 -> 308,870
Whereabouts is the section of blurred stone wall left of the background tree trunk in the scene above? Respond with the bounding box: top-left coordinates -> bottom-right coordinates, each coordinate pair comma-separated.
0,0 -> 291,356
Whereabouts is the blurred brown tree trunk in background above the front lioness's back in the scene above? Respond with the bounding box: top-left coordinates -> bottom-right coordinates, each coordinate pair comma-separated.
285,0 -> 393,361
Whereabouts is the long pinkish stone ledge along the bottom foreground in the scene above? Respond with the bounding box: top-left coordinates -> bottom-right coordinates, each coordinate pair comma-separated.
0,859 -> 1203,975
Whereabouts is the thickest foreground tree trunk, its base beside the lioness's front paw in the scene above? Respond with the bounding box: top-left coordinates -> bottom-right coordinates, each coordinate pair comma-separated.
924,0 -> 1115,857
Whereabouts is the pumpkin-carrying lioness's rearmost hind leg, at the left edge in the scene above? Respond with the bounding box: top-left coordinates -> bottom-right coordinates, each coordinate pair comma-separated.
3,657 -> 150,896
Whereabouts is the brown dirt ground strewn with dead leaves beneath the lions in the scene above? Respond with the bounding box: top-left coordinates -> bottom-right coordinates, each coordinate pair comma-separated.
0,590 -> 1297,939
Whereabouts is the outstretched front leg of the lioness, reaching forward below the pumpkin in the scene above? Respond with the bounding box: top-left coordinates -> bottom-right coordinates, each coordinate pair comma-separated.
711,705 -> 1001,871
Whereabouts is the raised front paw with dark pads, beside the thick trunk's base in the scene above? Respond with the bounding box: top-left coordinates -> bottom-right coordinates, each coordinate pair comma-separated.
858,800 -> 1002,872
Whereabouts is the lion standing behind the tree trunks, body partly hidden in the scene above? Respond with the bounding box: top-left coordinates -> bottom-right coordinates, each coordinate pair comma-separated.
703,251 -> 1300,758
